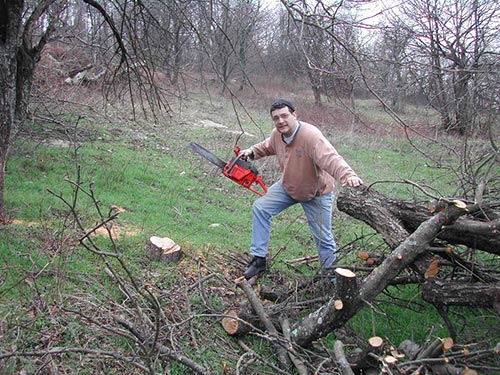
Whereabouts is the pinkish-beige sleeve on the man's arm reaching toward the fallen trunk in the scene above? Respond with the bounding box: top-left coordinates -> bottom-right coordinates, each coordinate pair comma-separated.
313,137 -> 357,184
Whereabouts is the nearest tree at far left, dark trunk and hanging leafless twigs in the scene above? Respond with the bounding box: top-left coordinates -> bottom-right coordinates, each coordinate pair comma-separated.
0,0 -> 173,220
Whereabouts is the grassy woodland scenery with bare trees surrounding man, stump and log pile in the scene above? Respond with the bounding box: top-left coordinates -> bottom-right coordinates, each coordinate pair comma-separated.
0,0 -> 500,374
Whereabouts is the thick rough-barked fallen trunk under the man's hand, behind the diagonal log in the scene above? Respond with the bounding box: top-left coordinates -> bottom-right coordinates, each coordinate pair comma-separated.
337,187 -> 500,255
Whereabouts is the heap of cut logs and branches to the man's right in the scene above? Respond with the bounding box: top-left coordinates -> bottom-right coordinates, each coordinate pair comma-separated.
223,187 -> 500,374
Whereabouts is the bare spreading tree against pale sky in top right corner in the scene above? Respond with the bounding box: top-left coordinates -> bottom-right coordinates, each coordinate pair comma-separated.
395,0 -> 500,135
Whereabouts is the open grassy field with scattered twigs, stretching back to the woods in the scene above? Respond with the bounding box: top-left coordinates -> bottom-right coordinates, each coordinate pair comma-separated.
0,86 -> 498,374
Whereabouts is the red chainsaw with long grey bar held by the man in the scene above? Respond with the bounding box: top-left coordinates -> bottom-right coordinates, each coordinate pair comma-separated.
189,142 -> 267,196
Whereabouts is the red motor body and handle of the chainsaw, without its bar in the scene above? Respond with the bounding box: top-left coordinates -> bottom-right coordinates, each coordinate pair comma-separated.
222,146 -> 267,196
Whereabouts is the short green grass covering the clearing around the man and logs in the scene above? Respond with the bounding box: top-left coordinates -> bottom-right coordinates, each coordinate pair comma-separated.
0,95 -> 498,374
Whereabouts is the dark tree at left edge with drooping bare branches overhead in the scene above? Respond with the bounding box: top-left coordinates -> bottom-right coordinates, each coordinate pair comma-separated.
0,0 -> 179,219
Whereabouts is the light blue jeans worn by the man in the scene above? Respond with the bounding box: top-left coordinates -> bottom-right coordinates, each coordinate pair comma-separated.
250,181 -> 337,268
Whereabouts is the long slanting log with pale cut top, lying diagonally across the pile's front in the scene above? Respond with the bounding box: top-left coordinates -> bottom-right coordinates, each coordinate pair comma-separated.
291,198 -> 469,347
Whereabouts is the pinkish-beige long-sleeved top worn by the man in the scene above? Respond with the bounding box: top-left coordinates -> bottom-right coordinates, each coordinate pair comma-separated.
252,122 -> 356,201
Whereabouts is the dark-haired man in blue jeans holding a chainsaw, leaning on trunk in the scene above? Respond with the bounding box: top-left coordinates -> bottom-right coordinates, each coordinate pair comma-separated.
242,99 -> 363,279
